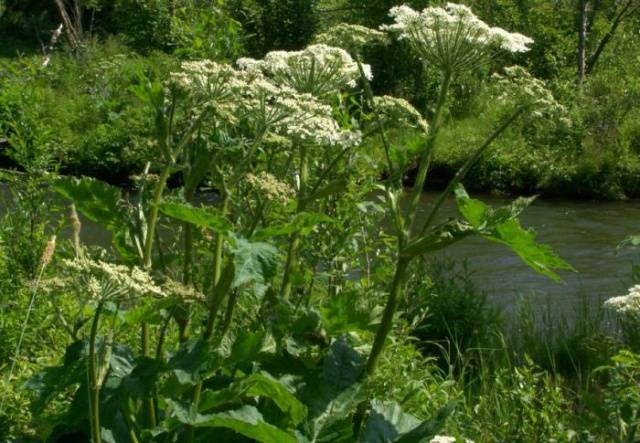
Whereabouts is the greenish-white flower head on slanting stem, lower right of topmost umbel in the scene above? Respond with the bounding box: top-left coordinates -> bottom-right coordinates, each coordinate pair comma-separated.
492,66 -> 567,118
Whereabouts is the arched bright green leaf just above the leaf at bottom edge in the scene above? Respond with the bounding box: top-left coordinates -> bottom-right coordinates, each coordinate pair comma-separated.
200,372 -> 307,425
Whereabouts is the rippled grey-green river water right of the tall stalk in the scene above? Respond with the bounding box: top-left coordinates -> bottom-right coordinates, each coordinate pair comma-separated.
420,193 -> 640,311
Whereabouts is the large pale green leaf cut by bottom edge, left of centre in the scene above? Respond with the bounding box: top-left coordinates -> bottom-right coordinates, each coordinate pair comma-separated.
164,400 -> 297,443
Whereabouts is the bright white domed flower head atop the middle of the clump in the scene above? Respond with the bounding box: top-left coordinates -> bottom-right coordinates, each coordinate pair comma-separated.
237,44 -> 373,97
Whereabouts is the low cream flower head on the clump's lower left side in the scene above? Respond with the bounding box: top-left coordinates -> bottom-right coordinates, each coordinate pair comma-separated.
63,258 -> 164,298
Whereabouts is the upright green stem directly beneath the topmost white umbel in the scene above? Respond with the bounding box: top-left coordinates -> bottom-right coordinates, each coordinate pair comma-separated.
405,72 -> 451,230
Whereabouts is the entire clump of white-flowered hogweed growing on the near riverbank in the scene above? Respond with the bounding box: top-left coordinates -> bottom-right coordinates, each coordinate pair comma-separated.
29,4 -> 570,443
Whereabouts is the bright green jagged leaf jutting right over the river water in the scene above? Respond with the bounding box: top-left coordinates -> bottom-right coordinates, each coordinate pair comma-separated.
456,185 -> 573,281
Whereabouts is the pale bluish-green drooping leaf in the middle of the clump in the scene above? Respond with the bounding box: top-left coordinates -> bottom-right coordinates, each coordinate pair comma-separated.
231,236 -> 278,297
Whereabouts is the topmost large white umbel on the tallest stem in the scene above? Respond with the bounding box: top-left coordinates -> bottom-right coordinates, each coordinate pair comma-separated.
382,3 -> 533,74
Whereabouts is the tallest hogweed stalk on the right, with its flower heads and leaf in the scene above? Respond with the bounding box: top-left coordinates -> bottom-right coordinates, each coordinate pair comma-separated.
352,3 -> 571,376
